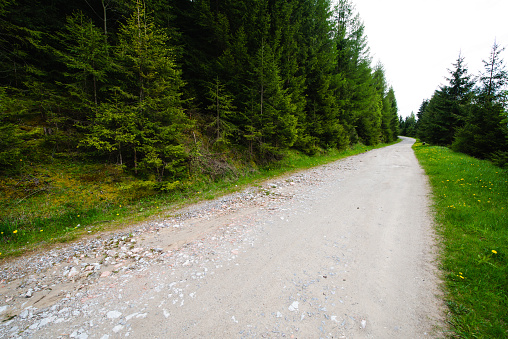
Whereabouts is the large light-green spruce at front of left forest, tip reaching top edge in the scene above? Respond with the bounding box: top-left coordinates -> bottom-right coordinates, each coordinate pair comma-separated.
83,0 -> 189,180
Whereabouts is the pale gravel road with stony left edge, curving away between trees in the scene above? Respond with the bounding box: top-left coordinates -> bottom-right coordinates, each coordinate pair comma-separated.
0,138 -> 443,339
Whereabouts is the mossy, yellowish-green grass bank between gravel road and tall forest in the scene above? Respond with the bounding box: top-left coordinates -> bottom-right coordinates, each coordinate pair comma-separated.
0,139 -> 400,260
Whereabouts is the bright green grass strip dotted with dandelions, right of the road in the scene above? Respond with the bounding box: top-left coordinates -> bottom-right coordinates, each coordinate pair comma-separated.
413,143 -> 508,338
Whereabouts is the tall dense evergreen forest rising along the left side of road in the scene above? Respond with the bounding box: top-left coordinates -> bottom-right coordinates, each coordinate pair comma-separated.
0,0 -> 398,181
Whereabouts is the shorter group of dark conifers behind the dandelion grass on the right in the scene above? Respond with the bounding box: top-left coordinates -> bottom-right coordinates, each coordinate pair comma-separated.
399,43 -> 508,166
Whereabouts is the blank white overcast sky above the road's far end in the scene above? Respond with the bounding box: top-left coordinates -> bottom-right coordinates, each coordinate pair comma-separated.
352,0 -> 508,116
